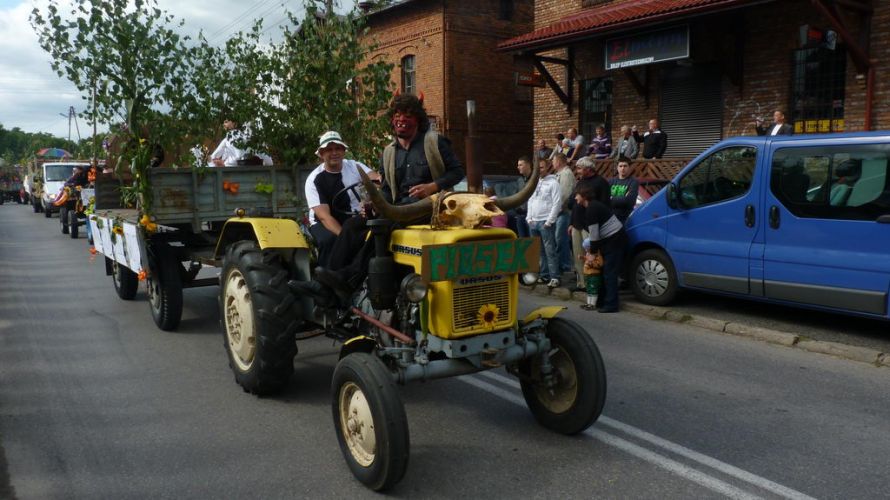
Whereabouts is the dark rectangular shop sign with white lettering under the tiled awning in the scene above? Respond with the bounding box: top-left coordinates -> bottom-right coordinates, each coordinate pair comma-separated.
605,26 -> 689,70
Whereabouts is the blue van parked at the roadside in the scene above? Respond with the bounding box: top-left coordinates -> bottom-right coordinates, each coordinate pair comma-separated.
627,131 -> 890,319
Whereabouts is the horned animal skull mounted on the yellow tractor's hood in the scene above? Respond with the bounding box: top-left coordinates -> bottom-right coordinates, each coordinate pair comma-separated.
359,169 -> 538,229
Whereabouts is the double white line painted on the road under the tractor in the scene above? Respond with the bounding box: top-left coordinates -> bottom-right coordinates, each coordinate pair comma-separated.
459,372 -> 815,500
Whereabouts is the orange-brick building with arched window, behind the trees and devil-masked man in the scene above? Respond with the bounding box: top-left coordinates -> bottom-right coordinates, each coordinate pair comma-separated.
367,0 -> 533,174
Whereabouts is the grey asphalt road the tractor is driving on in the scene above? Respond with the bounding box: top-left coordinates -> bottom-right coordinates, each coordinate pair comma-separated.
0,205 -> 890,499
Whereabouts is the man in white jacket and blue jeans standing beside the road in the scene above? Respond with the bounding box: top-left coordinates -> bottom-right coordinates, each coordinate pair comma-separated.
520,157 -> 562,288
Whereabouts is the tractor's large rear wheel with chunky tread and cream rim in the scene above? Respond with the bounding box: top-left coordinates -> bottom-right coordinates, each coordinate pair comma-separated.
219,241 -> 300,395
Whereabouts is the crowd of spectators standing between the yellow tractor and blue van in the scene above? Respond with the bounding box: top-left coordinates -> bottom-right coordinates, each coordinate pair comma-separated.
512,119 -> 667,313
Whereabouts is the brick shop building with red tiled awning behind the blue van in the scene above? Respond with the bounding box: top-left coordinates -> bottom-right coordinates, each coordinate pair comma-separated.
498,0 -> 890,162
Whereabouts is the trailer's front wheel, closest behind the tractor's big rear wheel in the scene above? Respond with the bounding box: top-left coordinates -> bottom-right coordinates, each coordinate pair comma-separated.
146,244 -> 182,332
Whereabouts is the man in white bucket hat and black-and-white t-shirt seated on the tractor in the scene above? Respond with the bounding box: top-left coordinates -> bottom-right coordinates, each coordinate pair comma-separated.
305,130 -> 380,267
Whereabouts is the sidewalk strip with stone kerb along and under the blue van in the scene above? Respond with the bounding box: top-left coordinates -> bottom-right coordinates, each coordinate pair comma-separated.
520,283 -> 890,367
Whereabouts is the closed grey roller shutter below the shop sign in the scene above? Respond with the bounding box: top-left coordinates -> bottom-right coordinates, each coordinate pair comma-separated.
659,66 -> 723,157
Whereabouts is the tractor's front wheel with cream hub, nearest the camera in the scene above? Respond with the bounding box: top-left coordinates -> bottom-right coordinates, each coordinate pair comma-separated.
331,352 -> 410,491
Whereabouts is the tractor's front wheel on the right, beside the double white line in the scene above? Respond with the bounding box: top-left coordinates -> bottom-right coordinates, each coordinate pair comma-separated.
520,318 -> 606,435
